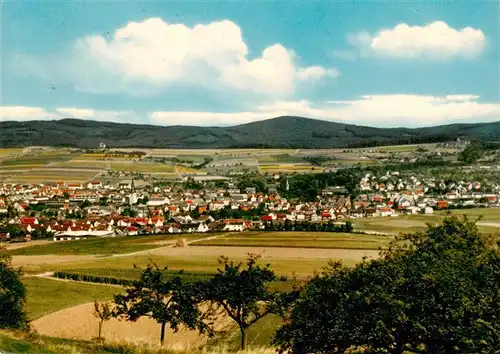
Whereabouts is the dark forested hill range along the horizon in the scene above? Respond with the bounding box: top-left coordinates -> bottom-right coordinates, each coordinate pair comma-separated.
0,117 -> 500,148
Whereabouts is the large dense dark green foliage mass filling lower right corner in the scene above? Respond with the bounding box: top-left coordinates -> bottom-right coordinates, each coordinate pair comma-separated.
275,217 -> 500,354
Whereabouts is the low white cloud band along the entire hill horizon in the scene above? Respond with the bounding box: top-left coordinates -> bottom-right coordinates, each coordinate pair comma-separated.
4,94 -> 500,127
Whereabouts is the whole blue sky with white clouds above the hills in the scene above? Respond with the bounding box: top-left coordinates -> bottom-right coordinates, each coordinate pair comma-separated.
0,0 -> 500,127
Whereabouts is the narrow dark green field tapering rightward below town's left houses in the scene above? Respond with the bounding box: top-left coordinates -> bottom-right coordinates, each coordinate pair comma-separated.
9,235 -> 202,256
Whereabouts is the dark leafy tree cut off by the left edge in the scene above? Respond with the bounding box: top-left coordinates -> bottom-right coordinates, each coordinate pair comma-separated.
0,246 -> 28,329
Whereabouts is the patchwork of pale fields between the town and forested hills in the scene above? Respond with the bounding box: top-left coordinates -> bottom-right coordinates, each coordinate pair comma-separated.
0,145 -> 434,183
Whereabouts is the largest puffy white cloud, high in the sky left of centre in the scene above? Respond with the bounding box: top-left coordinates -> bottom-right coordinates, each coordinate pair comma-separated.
30,18 -> 338,96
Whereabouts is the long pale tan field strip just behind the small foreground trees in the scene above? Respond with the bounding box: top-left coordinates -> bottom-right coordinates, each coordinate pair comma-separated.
13,246 -> 378,276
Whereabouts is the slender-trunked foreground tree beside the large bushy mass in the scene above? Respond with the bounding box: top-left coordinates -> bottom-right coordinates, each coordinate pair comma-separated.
203,254 -> 276,350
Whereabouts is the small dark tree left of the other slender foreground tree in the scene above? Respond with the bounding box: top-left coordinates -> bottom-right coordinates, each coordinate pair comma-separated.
115,265 -> 209,346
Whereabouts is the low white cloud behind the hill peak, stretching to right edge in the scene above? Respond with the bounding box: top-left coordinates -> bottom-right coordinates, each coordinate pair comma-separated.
150,94 -> 500,127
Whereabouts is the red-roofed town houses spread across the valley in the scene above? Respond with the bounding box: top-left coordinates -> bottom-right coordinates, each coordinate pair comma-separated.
0,172 -> 500,240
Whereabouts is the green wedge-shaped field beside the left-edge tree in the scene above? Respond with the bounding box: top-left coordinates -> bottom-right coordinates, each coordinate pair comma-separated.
23,277 -> 120,320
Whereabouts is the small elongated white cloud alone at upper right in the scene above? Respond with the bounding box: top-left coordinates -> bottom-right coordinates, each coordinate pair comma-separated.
334,21 -> 486,60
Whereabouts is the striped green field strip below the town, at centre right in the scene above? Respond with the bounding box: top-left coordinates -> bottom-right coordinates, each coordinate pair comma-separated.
194,232 -> 391,249
